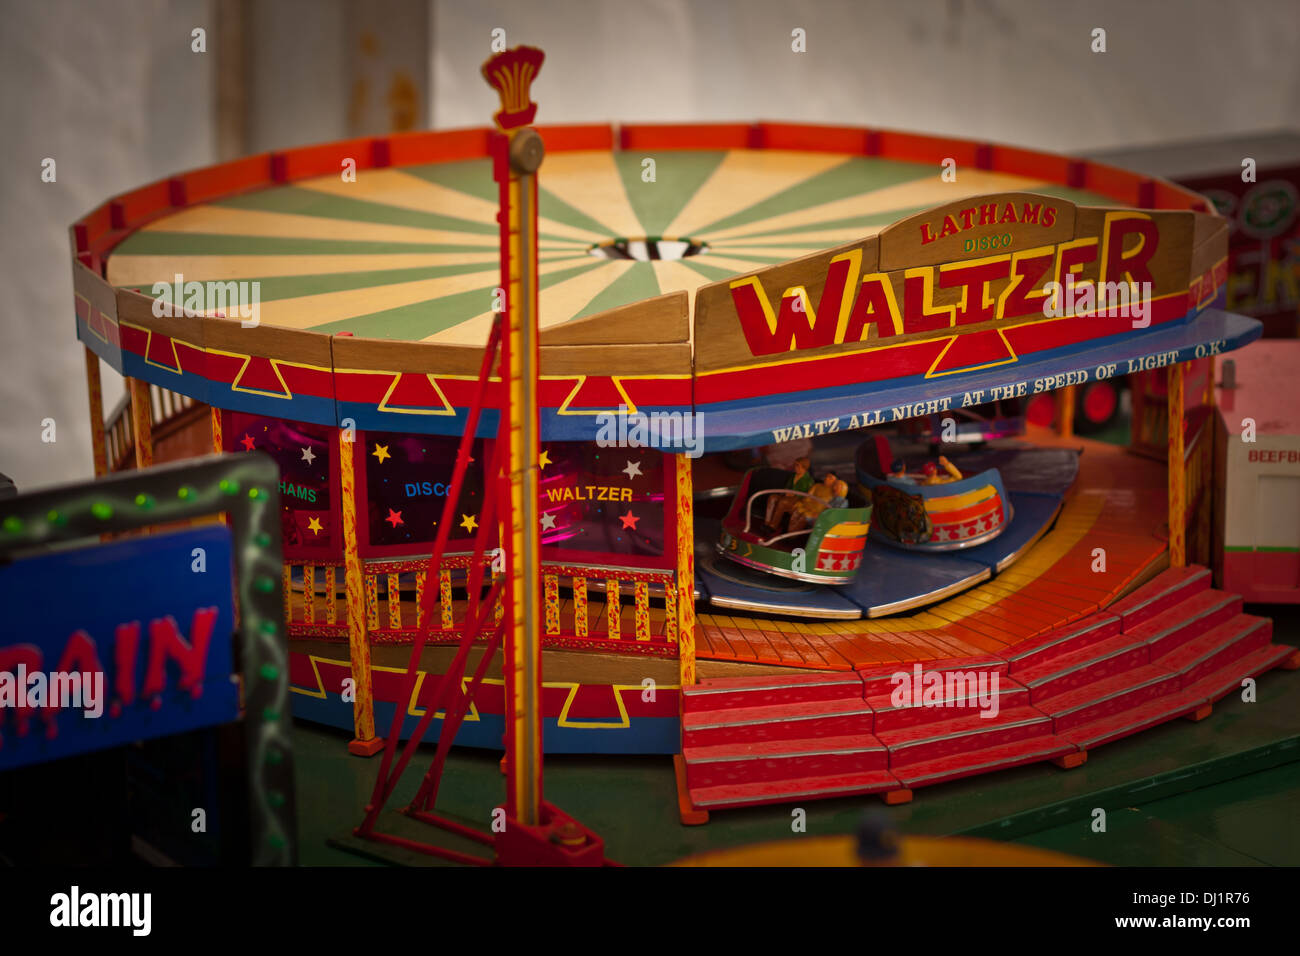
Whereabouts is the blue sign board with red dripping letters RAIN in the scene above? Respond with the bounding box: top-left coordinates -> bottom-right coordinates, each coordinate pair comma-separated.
0,524 -> 239,770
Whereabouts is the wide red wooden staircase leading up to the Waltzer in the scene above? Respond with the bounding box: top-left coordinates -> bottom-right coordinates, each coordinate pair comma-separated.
677,567 -> 1300,822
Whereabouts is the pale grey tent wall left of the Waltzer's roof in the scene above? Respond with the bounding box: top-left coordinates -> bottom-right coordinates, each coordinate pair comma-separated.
0,0 -> 216,490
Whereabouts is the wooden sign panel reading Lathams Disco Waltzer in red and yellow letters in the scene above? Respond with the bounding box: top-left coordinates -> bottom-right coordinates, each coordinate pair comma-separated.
696,193 -> 1213,378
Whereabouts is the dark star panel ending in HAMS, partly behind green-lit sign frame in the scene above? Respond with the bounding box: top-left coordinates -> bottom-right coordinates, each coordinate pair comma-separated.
221,411 -> 343,562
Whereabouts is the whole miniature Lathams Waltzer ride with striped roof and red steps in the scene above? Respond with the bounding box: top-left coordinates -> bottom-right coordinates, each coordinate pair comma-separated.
55,42 -> 1296,842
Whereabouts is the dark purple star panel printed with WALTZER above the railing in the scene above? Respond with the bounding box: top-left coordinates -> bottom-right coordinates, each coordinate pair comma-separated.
540,441 -> 675,566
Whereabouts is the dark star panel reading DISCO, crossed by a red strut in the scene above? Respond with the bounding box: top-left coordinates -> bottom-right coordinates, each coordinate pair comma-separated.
356,432 -> 495,557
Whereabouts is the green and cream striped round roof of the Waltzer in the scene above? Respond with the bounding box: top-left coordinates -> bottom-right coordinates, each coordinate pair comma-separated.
108,150 -> 1113,345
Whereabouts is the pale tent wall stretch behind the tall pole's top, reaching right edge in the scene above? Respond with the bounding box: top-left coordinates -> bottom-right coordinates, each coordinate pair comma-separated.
432,0 -> 1300,153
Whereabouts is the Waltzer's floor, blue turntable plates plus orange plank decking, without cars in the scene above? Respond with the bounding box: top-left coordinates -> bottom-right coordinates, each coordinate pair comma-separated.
696,429 -> 1167,676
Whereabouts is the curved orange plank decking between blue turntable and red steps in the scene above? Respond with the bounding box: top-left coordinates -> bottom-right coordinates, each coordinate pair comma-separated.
696,429 -> 1167,670
